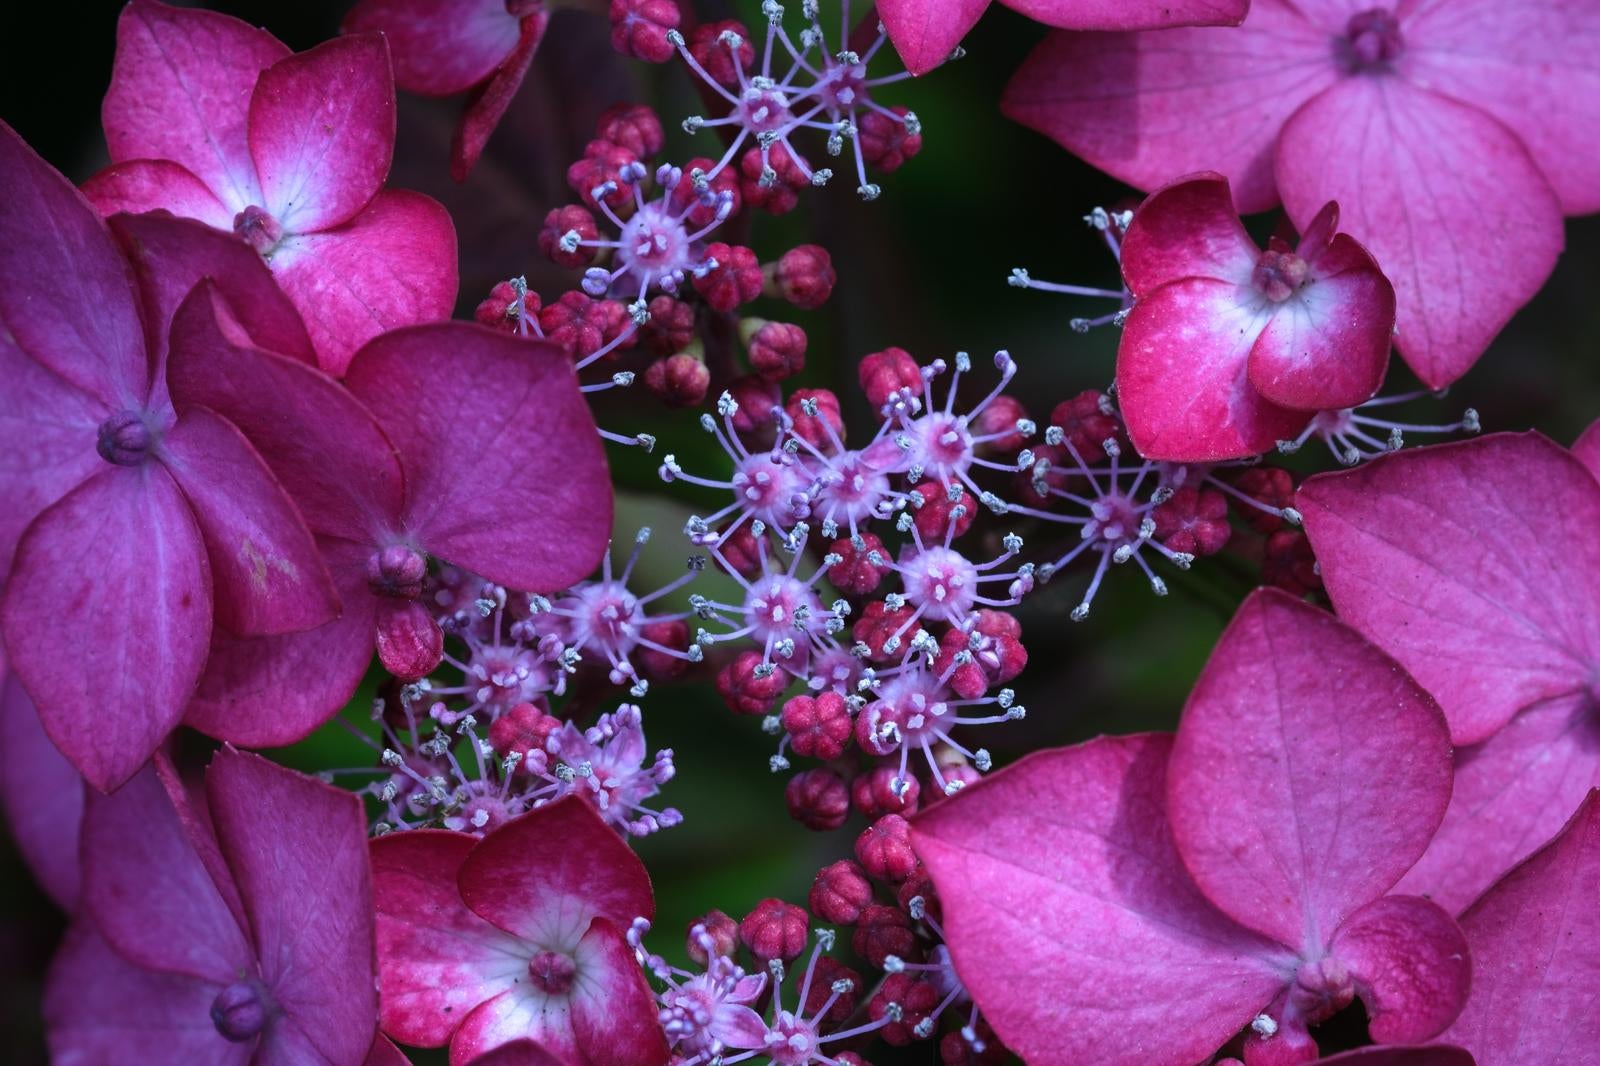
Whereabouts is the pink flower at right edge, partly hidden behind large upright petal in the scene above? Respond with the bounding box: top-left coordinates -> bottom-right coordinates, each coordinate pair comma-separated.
1296,434 -> 1600,911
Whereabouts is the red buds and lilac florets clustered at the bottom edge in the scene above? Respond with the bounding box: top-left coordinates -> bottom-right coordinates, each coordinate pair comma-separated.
629,832 -> 1006,1066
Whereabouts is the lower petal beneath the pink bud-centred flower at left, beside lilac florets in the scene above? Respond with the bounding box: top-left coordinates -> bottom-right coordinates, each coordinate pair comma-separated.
184,539 -> 376,747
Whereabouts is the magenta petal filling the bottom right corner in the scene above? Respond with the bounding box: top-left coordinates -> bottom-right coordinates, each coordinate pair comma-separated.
1442,792 -> 1600,1066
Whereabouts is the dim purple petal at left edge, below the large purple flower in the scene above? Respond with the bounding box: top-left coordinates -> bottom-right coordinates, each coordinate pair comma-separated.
0,667 -> 83,914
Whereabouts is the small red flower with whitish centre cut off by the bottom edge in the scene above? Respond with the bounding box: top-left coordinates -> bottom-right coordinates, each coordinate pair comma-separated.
371,797 -> 667,1066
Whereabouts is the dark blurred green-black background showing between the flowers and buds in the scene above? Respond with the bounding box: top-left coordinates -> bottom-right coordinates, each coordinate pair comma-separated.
0,0 -> 1600,1063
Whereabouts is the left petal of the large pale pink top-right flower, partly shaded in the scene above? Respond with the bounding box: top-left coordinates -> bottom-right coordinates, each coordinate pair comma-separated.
1002,10 -> 1337,211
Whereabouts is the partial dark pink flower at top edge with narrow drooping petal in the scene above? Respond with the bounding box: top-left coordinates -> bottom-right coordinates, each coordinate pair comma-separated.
342,0 -> 550,181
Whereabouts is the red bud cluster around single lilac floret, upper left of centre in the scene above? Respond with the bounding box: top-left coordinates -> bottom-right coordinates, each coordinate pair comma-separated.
477,104 -> 835,428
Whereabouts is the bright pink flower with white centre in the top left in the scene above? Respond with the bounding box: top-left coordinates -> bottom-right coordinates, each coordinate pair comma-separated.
83,0 -> 456,373
